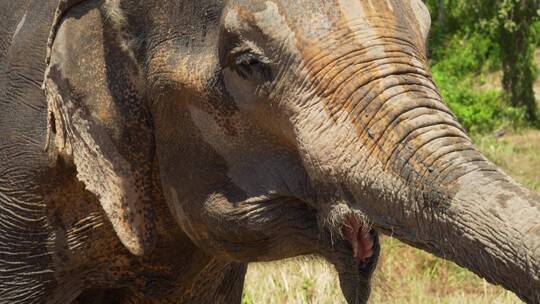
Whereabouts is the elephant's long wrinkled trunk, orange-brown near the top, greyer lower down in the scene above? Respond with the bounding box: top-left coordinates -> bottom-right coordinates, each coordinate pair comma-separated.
296,42 -> 540,303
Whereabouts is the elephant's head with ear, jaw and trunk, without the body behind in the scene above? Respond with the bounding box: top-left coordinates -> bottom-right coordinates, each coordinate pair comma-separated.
45,0 -> 540,303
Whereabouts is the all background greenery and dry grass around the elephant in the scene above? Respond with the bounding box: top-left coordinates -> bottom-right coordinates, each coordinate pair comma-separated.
243,0 -> 540,304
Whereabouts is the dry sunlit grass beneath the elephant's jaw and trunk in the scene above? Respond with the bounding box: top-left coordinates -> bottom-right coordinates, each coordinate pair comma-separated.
243,238 -> 521,304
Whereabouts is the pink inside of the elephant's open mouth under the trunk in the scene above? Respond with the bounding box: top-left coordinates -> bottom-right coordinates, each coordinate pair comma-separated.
343,218 -> 373,263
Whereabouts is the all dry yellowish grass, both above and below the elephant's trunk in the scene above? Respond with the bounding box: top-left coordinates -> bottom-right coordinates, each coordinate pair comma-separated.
244,130 -> 540,304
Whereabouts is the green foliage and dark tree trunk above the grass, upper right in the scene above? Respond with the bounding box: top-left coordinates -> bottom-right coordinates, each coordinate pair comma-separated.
426,0 -> 540,130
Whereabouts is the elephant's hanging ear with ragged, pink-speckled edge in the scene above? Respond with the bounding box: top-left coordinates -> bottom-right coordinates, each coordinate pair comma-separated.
44,0 -> 154,255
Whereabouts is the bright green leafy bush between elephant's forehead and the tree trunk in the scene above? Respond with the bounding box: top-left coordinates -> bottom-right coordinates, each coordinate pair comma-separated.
424,5 -> 540,133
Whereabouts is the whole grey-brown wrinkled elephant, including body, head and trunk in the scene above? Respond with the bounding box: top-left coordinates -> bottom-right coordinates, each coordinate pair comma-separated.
0,0 -> 540,303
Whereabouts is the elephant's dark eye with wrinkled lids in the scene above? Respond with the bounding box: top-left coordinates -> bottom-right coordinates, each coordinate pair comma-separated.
234,50 -> 272,81
